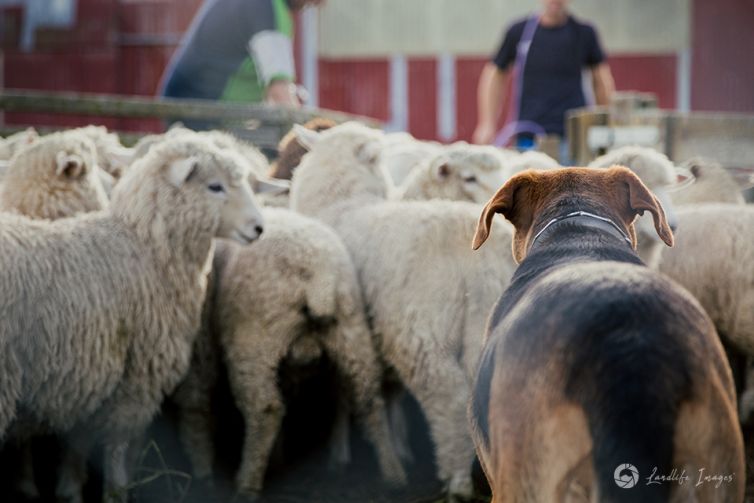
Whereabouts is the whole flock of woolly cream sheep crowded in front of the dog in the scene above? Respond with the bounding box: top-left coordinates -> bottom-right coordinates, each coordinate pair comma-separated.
0,119 -> 754,502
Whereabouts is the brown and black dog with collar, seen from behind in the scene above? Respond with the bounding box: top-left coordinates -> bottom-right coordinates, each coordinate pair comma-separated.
470,167 -> 745,503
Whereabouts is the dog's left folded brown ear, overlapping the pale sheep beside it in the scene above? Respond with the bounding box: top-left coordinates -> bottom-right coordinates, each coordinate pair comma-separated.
471,171 -> 539,254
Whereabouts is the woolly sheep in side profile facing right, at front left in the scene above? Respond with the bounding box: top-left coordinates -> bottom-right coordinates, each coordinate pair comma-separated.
0,134 -> 263,499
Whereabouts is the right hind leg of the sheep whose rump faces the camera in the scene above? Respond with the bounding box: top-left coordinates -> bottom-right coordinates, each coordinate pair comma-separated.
325,321 -> 406,485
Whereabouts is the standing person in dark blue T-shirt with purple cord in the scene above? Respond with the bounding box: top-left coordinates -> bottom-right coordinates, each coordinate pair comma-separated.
473,0 -> 614,154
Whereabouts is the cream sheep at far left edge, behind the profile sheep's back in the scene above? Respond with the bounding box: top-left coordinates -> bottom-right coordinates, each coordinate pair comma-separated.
0,131 -> 107,220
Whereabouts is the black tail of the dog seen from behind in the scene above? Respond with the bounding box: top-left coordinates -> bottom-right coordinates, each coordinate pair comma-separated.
576,324 -> 690,503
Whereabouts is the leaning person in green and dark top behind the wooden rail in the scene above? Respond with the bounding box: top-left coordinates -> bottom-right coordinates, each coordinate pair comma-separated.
158,0 -> 324,112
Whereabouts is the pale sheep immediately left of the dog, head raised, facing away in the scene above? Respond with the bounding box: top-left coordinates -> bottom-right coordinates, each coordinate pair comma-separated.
291,123 -> 515,496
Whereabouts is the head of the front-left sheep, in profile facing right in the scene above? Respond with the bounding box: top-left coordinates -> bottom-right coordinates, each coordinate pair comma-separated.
112,134 -> 264,244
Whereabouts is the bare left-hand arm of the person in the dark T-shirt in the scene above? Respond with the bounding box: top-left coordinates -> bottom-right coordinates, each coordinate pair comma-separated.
472,62 -> 510,144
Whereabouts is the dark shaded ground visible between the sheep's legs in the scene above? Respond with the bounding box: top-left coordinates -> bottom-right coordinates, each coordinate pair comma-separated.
0,360 -> 754,503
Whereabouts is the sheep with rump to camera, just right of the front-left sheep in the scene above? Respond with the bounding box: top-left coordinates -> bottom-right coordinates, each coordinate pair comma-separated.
176,209 -> 406,495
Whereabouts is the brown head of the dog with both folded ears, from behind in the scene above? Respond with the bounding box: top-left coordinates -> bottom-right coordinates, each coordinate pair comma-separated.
473,166 -> 673,262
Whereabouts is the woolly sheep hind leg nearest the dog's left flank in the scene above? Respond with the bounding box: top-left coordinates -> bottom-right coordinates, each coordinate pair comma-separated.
395,348 -> 474,499
